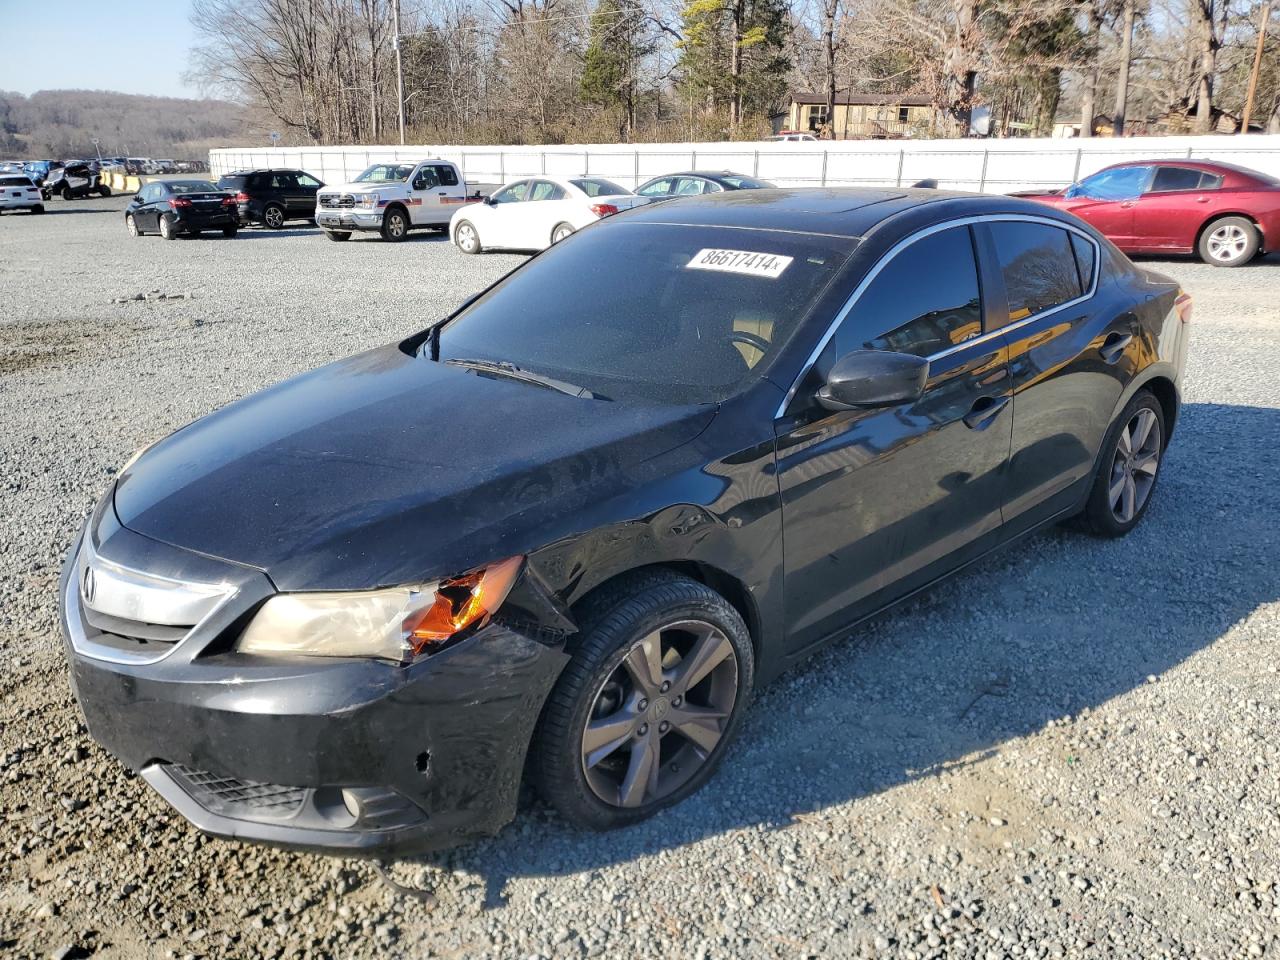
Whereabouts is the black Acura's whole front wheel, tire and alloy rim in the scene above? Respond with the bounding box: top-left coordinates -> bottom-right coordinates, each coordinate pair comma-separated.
532,572 -> 755,829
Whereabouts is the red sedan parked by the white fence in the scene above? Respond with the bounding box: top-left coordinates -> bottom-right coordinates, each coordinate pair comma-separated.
1021,160 -> 1280,266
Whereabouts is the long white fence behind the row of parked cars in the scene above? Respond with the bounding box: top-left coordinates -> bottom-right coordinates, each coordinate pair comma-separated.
209,134 -> 1280,193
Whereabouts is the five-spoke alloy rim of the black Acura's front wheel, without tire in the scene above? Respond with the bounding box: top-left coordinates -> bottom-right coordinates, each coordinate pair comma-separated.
581,620 -> 739,808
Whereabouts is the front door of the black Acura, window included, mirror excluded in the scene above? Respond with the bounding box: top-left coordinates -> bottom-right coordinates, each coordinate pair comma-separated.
777,225 -> 1012,650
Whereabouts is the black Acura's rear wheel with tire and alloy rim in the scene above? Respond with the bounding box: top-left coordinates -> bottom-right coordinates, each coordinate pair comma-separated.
1082,390 -> 1167,538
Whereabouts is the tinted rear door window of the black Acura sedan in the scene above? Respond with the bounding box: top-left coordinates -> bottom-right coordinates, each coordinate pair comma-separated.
991,220 -> 1080,321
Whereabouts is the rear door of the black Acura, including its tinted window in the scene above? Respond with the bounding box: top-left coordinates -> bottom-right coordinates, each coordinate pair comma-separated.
977,218 -> 1138,536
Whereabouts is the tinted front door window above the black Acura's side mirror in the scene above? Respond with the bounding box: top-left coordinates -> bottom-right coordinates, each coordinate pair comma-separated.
826,227 -> 982,364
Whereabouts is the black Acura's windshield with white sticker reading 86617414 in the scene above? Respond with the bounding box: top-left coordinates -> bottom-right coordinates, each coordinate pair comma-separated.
439,221 -> 855,403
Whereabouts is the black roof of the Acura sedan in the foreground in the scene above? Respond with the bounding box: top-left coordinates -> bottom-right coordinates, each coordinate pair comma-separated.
614,187 -> 1079,238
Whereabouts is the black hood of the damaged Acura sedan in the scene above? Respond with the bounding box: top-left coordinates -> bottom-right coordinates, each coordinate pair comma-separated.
114,346 -> 716,590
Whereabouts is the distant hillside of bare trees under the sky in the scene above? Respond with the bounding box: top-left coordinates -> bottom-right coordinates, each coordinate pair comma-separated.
0,90 -> 257,157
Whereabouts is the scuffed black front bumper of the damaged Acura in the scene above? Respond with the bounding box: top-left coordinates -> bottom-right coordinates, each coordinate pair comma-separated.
61,503 -> 566,855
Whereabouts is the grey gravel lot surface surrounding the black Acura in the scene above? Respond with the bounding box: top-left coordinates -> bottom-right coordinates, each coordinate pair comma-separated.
0,200 -> 1280,960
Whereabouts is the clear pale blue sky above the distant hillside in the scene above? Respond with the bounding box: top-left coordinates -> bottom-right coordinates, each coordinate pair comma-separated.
0,0 -> 200,97
